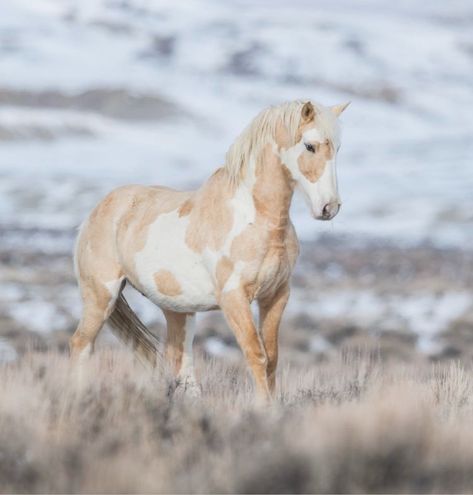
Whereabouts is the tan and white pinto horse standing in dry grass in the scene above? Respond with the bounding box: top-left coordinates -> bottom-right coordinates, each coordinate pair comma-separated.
70,100 -> 348,399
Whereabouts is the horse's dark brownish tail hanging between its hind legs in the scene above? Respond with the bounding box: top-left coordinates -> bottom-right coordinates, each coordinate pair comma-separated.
108,294 -> 160,368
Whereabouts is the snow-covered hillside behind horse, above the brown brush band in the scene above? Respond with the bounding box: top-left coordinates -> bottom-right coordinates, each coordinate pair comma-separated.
0,0 -> 473,245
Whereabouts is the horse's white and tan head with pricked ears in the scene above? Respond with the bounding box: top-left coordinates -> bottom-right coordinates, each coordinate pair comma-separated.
281,101 -> 348,220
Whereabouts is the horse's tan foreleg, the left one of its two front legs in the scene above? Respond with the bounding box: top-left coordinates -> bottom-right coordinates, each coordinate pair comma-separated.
220,290 -> 269,398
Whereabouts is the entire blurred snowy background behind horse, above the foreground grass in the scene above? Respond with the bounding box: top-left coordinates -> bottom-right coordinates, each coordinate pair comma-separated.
0,0 -> 473,361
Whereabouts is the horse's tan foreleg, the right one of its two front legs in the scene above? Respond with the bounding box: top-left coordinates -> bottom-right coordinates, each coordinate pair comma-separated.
258,284 -> 289,392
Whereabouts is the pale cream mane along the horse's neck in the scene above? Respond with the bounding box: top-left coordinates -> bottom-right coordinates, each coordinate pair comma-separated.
224,100 -> 317,184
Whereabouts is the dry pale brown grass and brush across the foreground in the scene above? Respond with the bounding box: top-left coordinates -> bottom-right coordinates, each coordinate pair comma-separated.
0,351 -> 473,493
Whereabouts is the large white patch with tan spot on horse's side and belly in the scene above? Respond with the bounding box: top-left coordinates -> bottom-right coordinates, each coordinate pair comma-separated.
130,212 -> 217,312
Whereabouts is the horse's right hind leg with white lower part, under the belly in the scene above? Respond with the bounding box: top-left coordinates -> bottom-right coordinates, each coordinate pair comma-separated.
163,310 -> 201,395
